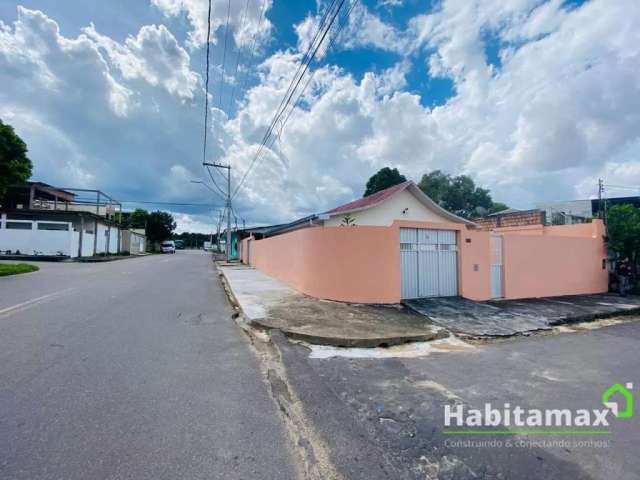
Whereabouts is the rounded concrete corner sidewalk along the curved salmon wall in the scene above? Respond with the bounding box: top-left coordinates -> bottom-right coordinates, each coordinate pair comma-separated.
218,263 -> 448,347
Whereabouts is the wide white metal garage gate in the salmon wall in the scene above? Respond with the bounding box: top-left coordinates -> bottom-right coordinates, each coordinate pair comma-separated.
400,228 -> 458,298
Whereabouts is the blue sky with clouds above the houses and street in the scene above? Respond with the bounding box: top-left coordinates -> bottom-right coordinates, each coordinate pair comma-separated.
0,0 -> 640,232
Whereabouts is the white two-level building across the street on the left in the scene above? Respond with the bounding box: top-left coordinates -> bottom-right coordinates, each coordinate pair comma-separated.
0,182 -> 127,258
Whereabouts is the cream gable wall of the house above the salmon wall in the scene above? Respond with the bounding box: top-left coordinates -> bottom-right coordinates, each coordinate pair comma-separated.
324,190 -> 451,227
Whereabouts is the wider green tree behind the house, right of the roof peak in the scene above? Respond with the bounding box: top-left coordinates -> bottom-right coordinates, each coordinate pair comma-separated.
418,170 -> 507,218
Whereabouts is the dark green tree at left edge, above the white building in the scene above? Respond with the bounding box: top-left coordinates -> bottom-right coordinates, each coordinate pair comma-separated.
0,120 -> 33,199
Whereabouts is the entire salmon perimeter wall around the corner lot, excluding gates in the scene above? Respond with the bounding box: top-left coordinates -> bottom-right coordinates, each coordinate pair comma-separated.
248,221 -> 608,303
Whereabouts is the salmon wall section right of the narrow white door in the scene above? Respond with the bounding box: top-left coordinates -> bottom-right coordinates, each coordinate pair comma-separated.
503,235 -> 609,299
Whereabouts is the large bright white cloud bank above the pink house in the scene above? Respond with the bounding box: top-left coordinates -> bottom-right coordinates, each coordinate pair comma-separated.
228,0 -> 640,219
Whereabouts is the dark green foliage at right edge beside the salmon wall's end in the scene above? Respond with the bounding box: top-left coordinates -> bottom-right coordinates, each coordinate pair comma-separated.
607,205 -> 640,262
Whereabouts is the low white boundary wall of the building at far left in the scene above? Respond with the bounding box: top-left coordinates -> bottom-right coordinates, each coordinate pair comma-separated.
0,215 -> 78,257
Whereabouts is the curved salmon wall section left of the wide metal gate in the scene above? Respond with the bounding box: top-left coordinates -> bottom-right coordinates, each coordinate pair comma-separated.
251,227 -> 400,303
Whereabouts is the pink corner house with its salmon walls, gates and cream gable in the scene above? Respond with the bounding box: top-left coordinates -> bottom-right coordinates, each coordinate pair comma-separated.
242,181 -> 608,304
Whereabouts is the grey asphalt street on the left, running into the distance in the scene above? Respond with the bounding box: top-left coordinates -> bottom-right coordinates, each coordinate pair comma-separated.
0,252 -> 295,480
